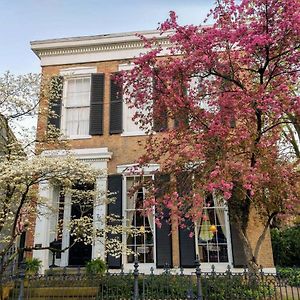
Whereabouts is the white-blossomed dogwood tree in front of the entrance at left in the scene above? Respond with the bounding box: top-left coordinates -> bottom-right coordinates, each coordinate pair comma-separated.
0,72 -> 138,275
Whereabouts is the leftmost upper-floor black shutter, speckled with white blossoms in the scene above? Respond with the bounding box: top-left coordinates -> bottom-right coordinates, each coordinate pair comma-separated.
48,76 -> 63,129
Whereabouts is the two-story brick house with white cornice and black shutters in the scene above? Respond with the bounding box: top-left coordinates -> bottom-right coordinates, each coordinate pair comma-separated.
31,31 -> 273,271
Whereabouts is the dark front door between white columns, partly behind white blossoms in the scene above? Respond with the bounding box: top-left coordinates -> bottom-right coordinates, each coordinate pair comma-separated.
68,187 -> 93,266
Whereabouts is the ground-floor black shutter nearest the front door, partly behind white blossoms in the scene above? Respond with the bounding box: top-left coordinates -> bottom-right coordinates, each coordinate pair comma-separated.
107,175 -> 122,269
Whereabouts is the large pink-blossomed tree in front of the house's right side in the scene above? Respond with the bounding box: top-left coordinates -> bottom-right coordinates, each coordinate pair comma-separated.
122,0 -> 300,270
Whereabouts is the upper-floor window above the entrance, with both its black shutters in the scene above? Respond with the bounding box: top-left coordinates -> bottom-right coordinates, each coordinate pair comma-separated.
48,67 -> 105,139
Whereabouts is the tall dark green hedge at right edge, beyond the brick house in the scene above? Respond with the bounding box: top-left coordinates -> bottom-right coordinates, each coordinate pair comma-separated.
271,225 -> 300,267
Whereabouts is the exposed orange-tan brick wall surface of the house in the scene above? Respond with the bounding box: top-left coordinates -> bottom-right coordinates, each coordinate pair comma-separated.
37,61 -> 274,267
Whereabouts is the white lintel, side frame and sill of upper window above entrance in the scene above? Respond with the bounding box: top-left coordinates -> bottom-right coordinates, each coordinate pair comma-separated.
59,67 -> 97,140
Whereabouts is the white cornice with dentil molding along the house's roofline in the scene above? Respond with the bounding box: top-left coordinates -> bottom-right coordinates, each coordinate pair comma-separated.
31,31 -> 171,66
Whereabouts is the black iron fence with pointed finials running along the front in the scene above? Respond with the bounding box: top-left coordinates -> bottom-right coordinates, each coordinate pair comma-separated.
2,261 -> 300,300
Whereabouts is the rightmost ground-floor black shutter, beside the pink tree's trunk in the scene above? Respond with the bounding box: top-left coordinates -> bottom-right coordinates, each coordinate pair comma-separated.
228,201 -> 247,268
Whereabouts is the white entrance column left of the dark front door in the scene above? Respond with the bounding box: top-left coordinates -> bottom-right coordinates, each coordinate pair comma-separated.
33,182 -> 53,273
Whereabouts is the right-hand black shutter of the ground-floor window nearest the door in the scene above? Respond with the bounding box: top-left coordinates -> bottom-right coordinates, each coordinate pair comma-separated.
156,174 -> 173,268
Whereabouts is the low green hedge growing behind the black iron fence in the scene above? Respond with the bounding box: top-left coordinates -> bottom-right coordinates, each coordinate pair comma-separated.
100,274 -> 274,300
